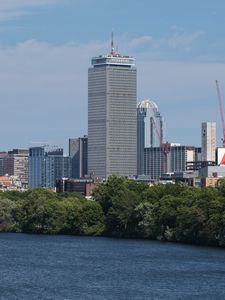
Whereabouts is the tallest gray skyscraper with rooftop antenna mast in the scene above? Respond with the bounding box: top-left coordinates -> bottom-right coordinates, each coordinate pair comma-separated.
88,40 -> 137,178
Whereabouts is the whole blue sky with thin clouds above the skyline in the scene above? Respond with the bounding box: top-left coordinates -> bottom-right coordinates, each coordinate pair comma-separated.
0,0 -> 225,151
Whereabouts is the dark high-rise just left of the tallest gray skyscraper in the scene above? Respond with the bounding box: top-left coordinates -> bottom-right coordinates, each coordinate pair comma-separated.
69,135 -> 88,178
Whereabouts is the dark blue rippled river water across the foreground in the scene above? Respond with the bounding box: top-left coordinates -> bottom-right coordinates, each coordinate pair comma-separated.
0,234 -> 225,300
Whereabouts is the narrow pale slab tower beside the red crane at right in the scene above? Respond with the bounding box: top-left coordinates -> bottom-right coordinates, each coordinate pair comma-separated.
201,122 -> 216,162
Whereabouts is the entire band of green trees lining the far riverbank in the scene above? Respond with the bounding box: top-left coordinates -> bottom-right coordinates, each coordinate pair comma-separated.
0,176 -> 225,247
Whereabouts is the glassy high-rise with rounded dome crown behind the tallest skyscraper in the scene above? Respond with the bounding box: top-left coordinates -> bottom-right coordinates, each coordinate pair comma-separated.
137,99 -> 164,175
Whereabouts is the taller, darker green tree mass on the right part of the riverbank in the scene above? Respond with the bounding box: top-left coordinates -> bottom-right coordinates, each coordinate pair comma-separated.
94,176 -> 225,246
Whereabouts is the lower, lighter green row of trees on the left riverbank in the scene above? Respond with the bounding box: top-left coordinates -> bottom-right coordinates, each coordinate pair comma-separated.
0,189 -> 105,235
